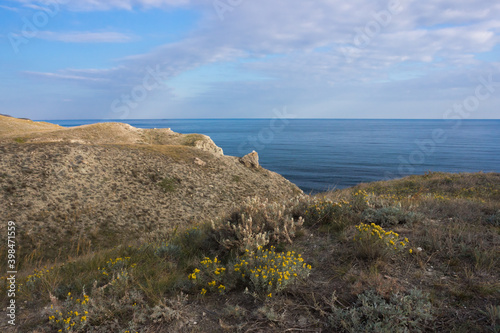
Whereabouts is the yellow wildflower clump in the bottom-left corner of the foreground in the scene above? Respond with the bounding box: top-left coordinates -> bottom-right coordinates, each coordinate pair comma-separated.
49,292 -> 90,332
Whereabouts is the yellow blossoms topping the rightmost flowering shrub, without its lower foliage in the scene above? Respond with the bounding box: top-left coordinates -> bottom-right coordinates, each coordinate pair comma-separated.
354,223 -> 409,251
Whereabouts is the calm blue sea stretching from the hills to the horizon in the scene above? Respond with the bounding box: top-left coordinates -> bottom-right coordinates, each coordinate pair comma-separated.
49,119 -> 500,193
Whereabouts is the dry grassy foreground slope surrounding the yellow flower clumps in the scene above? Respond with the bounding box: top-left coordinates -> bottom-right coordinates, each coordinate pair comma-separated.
1,163 -> 500,332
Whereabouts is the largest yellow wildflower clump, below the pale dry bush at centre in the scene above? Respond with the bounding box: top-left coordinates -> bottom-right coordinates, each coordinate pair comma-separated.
234,246 -> 311,297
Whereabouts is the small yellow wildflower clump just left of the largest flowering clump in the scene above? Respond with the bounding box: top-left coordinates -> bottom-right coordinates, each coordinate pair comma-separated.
188,257 -> 226,295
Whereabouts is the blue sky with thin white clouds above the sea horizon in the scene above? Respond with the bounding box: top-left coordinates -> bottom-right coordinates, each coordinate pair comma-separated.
0,0 -> 500,120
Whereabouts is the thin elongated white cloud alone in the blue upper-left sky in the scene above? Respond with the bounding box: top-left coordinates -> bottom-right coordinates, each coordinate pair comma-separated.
37,31 -> 137,43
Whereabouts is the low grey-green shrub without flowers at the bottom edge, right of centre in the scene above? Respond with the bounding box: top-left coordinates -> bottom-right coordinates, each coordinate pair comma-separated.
329,289 -> 433,333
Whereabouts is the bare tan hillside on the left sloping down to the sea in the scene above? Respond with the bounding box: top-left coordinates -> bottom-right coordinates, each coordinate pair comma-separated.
0,117 -> 301,258
